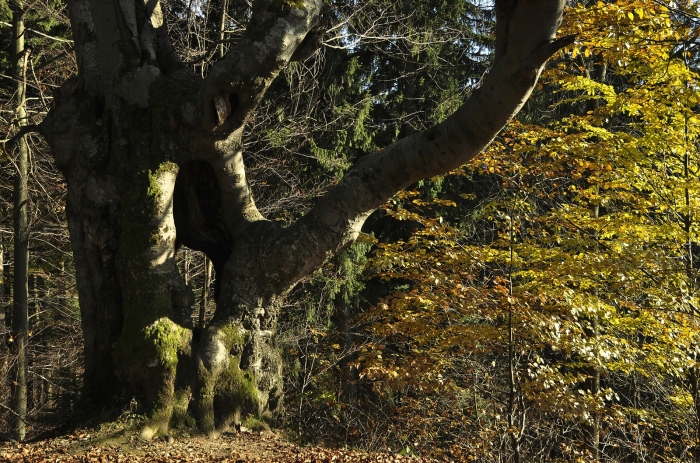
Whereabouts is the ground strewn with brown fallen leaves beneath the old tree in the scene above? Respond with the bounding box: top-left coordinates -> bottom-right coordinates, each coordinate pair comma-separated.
0,426 -> 435,463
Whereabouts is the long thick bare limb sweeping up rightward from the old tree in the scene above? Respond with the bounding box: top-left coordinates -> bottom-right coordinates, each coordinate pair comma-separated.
268,0 -> 575,290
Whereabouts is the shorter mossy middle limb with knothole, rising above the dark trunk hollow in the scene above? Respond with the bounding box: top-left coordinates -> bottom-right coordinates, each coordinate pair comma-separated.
193,0 -> 323,239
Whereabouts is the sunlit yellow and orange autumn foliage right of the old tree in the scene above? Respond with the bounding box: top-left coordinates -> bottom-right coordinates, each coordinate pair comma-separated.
358,0 -> 700,459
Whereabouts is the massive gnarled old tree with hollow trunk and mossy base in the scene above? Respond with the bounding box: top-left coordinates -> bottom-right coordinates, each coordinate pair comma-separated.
30,0 -> 573,438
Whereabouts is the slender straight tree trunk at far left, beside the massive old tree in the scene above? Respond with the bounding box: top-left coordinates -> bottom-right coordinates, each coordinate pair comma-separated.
12,2 -> 29,441
